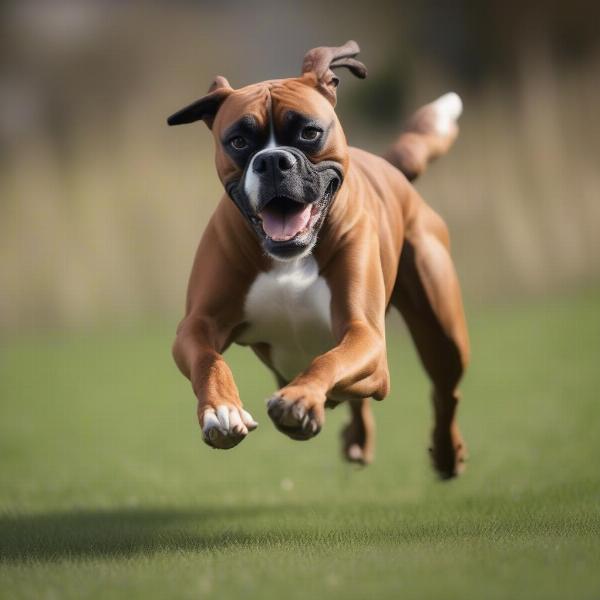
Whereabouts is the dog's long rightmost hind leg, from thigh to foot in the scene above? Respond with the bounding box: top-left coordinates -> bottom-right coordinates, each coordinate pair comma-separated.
392,208 -> 469,479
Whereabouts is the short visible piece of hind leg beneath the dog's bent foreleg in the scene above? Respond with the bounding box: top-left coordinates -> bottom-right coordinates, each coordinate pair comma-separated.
341,398 -> 375,465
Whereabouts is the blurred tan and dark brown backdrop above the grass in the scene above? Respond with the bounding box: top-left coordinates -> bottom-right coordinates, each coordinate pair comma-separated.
0,0 -> 600,332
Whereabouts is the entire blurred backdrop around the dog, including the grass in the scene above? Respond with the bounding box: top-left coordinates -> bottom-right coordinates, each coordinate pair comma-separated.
0,0 -> 600,600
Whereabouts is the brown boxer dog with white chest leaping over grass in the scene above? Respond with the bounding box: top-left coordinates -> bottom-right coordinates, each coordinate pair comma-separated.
168,41 -> 469,478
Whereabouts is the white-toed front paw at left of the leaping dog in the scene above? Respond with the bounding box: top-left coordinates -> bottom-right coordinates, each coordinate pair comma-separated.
199,404 -> 258,450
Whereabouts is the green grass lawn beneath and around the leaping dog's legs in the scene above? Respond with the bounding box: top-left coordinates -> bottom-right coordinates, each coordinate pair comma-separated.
0,291 -> 600,600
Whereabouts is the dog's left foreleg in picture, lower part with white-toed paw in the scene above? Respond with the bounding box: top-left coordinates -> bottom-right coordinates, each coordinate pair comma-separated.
173,315 -> 258,450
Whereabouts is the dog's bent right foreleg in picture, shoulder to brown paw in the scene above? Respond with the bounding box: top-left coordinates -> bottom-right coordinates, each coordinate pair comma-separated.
268,223 -> 389,440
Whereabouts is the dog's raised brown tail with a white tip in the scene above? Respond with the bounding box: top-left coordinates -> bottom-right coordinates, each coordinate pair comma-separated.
384,92 -> 462,181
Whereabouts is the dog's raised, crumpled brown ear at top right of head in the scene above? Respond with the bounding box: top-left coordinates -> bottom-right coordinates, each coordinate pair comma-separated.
302,40 -> 367,106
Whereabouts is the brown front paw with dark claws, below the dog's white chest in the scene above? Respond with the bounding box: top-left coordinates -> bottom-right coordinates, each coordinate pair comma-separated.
267,385 -> 325,440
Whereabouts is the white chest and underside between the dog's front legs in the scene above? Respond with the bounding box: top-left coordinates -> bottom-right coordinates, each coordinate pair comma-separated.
237,256 -> 334,380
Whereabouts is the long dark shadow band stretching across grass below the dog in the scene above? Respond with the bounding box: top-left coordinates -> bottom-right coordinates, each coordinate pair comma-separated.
0,482 -> 600,563
